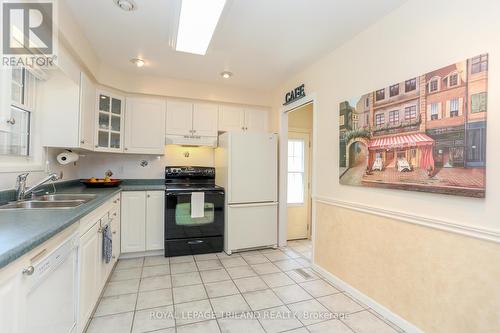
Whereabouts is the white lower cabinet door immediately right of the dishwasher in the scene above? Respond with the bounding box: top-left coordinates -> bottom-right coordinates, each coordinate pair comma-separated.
78,222 -> 101,332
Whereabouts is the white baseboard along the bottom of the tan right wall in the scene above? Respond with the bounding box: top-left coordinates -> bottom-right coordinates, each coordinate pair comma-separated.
311,264 -> 424,333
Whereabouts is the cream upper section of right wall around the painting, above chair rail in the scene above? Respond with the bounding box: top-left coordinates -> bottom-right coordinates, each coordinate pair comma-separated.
274,0 -> 500,231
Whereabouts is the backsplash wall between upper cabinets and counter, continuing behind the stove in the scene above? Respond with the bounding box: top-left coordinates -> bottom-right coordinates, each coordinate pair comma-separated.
78,145 -> 214,179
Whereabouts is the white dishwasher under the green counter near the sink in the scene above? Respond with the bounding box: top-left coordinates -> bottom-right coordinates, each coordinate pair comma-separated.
20,234 -> 79,333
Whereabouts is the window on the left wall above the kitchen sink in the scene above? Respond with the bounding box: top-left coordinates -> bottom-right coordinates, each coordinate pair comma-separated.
0,68 -> 36,157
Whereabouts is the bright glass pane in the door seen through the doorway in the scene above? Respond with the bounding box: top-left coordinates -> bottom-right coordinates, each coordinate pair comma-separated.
287,139 -> 305,205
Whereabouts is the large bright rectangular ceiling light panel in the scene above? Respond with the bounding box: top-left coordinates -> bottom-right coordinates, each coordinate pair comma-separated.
175,0 -> 226,55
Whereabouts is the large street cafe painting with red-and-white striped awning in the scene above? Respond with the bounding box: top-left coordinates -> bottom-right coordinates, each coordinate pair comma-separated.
339,54 -> 488,198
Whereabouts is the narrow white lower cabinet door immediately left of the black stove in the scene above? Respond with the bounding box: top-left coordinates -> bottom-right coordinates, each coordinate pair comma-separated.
146,191 -> 165,251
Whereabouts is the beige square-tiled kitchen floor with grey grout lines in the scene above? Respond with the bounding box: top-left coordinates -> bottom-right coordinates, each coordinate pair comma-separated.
87,240 -> 402,333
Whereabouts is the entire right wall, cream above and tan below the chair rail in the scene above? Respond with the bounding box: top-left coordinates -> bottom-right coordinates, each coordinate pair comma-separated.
273,0 -> 500,333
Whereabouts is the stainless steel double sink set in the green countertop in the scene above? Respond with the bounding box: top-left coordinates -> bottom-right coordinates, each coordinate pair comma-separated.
0,194 -> 97,210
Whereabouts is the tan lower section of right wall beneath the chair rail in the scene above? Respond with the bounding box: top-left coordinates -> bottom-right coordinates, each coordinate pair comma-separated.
314,203 -> 500,333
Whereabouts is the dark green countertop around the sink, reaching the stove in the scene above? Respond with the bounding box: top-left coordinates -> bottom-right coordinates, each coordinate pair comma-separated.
0,179 -> 165,268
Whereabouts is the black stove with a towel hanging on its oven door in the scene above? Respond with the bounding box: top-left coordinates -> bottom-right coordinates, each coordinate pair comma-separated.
165,166 -> 224,257
